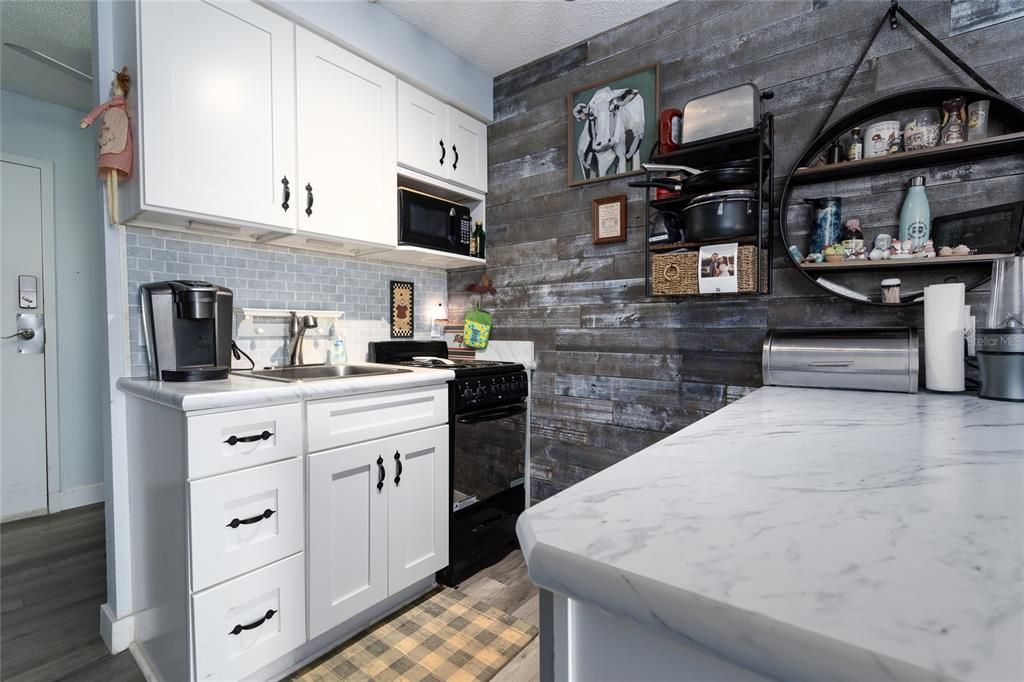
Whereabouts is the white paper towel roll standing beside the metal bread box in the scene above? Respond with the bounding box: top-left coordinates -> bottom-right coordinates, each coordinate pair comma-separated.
925,284 -> 964,391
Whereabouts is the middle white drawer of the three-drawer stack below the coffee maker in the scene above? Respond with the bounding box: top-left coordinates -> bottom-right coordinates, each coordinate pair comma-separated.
188,459 -> 304,591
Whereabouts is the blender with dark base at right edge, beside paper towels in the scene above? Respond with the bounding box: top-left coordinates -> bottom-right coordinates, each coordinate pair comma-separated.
976,255 -> 1024,402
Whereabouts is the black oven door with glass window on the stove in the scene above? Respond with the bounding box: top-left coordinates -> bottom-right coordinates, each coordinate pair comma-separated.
452,402 -> 526,511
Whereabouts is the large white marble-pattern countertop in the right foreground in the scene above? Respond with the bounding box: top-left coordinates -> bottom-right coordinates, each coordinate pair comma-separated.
518,387 -> 1024,682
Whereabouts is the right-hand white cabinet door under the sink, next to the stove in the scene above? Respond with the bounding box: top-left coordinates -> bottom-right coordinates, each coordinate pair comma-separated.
384,426 -> 449,594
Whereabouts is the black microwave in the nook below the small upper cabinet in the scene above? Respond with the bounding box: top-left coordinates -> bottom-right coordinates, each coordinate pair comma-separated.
398,187 -> 473,256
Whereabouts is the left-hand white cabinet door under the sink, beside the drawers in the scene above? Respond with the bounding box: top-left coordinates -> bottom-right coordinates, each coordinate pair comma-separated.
307,440 -> 390,639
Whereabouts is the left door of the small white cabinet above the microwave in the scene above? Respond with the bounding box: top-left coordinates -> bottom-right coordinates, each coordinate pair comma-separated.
398,81 -> 454,177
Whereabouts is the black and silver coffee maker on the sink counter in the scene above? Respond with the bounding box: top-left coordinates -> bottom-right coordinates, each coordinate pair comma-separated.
139,280 -> 232,381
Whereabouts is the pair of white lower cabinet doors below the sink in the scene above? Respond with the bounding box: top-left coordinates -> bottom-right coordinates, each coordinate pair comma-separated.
307,426 -> 449,638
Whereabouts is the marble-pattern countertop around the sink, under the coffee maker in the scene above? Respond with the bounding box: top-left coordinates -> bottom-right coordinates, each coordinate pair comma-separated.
118,363 -> 455,412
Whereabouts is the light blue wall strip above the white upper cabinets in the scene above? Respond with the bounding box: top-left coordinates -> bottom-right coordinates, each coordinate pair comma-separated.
267,0 -> 494,121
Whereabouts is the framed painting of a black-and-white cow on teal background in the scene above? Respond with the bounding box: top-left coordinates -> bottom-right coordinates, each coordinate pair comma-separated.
568,63 -> 662,186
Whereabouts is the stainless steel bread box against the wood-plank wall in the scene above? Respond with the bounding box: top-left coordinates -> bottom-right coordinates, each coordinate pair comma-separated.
761,328 -> 919,393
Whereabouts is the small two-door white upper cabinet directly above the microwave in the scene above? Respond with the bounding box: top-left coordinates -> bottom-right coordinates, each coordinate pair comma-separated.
398,81 -> 487,191
